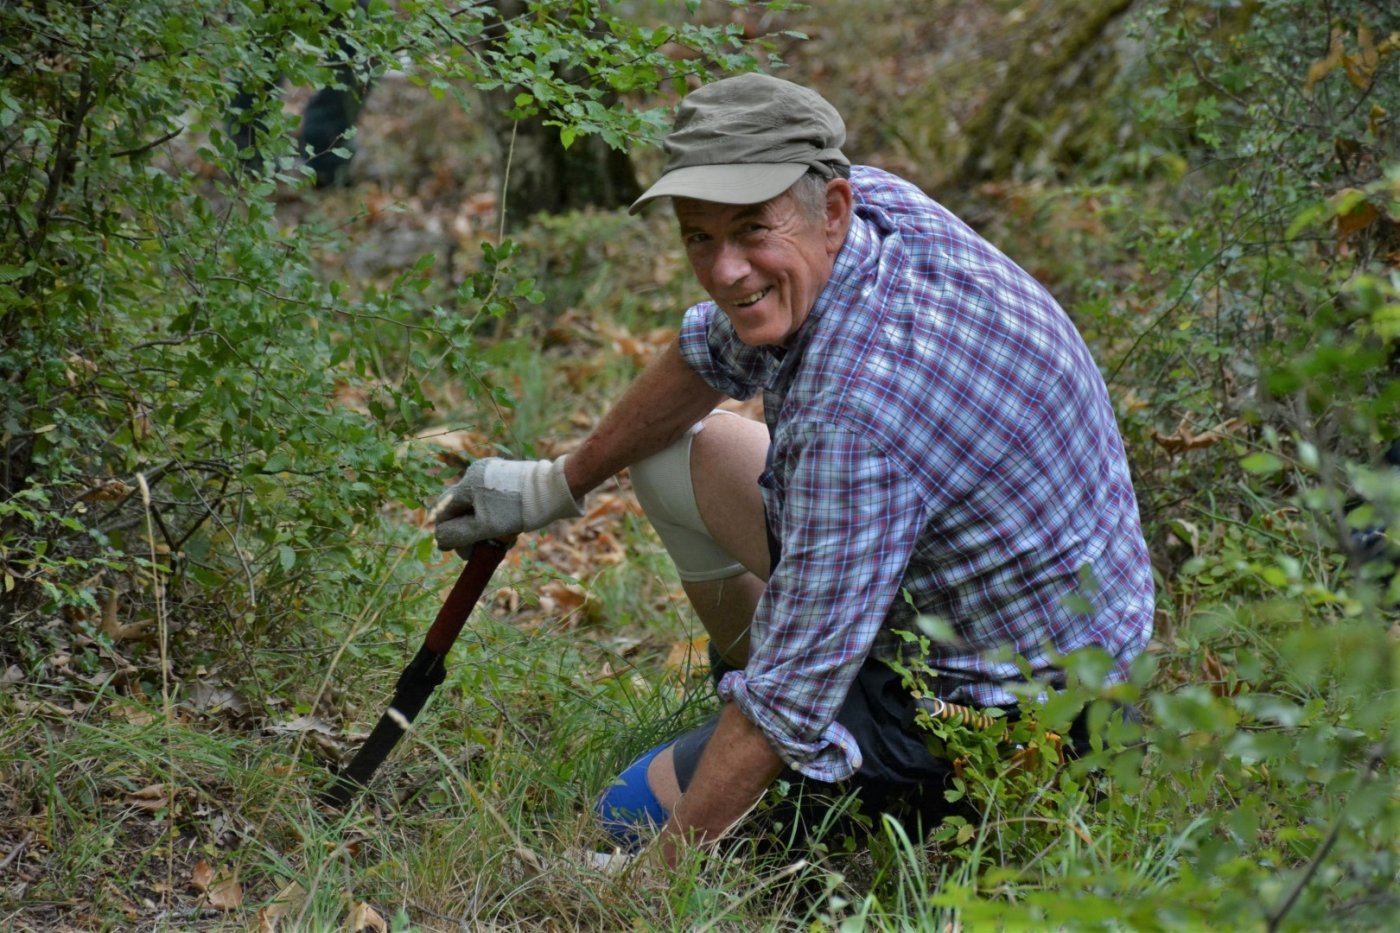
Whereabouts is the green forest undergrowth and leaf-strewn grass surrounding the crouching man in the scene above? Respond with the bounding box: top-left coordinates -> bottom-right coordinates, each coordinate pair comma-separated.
0,0 -> 1400,930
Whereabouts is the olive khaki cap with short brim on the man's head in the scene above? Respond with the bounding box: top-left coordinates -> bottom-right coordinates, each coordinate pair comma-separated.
629,74 -> 850,214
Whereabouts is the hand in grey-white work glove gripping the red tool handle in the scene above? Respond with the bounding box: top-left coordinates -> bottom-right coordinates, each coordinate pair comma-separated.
428,457 -> 584,551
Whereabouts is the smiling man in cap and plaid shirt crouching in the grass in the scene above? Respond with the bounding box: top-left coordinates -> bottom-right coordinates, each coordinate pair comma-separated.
437,74 -> 1152,863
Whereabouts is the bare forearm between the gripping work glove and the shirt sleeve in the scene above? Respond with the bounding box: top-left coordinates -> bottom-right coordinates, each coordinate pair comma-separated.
564,334 -> 722,496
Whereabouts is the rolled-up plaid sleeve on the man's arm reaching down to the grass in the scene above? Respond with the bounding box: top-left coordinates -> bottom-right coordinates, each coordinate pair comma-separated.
720,424 -> 925,782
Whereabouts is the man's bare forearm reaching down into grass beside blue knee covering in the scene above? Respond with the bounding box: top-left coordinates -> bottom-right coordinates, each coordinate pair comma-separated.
659,703 -> 783,864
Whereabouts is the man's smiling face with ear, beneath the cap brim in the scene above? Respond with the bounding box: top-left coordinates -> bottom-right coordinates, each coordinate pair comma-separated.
676,179 -> 851,346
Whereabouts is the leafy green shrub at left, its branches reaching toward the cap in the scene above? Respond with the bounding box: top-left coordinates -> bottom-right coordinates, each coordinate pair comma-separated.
0,0 -> 789,654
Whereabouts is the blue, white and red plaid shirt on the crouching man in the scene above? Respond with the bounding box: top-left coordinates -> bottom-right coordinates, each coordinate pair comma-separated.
680,167 -> 1152,780
